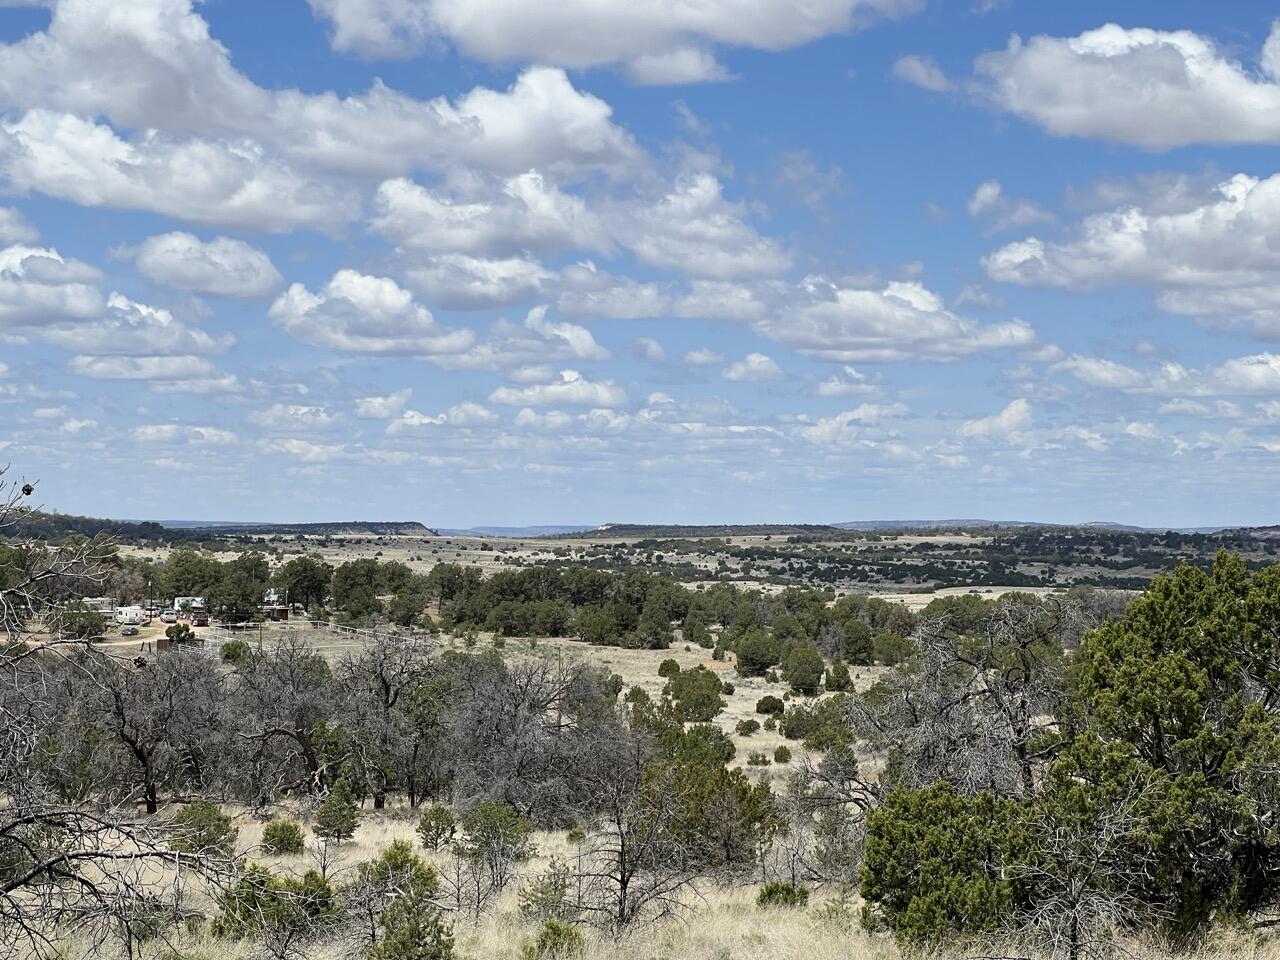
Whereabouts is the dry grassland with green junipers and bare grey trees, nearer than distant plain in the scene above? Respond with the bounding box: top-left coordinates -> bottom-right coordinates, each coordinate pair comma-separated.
0,471 -> 1280,960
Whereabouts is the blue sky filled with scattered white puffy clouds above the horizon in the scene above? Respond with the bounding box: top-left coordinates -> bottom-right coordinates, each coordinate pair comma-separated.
0,0 -> 1280,526
